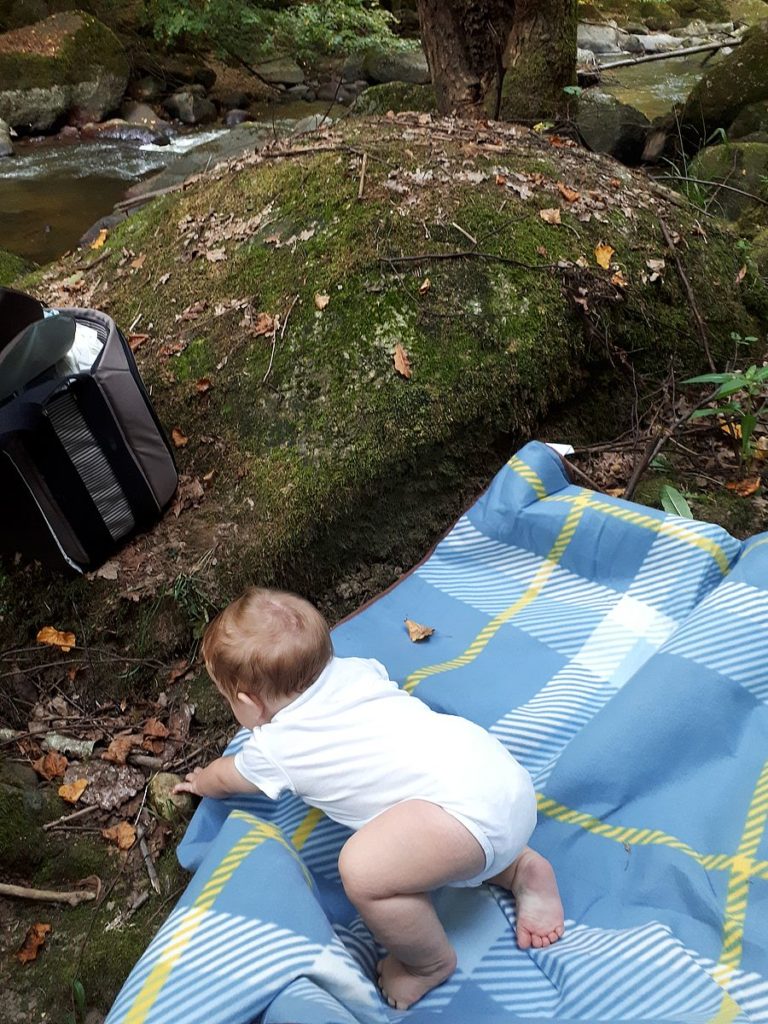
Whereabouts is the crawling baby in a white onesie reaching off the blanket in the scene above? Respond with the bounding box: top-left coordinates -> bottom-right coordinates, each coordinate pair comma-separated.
176,589 -> 563,1010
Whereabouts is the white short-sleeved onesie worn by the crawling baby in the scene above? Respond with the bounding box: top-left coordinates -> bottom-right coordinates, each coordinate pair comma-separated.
234,657 -> 537,886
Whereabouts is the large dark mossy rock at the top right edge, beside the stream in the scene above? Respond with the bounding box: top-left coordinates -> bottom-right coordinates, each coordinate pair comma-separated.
678,19 -> 768,151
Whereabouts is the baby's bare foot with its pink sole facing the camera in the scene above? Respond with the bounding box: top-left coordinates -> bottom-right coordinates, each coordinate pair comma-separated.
488,846 -> 563,949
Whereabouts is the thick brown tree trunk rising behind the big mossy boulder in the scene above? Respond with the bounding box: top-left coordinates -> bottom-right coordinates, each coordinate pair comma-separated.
419,0 -> 577,120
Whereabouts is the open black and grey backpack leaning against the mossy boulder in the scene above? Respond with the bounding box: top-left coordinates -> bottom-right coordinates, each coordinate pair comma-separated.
0,289 -> 178,571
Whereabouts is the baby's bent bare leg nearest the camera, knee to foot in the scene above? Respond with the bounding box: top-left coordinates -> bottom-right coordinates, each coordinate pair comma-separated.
339,800 -> 485,1010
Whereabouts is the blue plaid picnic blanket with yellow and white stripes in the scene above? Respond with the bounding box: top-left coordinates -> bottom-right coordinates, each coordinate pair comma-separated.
108,442 -> 768,1024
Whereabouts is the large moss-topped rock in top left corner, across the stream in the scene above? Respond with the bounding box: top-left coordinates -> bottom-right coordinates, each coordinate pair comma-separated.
0,11 -> 128,132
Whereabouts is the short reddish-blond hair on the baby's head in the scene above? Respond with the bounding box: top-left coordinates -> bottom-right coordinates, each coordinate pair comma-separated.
202,587 -> 333,698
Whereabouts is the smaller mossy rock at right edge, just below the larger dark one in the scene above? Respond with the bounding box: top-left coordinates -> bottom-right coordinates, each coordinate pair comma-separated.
688,141 -> 768,220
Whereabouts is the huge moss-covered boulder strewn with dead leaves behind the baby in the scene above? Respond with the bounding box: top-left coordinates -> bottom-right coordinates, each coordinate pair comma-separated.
6,115 -> 760,679
